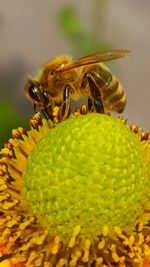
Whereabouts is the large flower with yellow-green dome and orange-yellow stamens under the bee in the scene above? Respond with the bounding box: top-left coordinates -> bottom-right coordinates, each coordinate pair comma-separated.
0,109 -> 150,267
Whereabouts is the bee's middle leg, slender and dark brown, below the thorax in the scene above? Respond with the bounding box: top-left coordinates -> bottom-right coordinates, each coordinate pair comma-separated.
60,85 -> 71,120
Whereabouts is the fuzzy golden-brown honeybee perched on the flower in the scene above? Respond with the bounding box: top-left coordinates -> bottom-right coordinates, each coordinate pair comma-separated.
25,49 -> 129,119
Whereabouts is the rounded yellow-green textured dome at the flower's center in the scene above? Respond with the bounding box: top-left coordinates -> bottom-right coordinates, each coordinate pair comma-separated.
24,114 -> 150,238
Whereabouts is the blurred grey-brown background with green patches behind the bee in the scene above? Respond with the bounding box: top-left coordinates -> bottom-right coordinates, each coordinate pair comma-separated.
0,0 -> 150,147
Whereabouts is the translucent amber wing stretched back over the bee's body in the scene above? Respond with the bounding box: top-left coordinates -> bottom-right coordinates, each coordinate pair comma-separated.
57,49 -> 129,72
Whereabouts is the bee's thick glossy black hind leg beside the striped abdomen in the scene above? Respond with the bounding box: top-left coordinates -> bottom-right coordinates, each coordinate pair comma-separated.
86,73 -> 104,113
